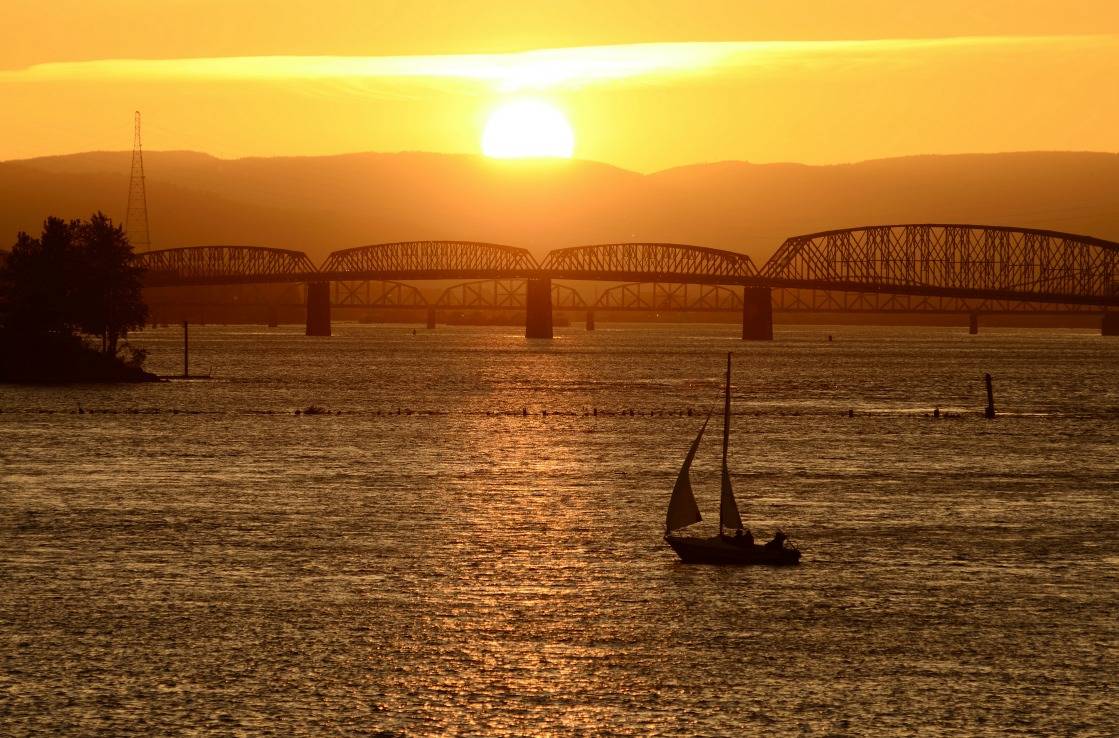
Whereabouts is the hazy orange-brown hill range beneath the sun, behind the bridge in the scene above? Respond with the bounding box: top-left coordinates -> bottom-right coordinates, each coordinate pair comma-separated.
0,151 -> 1119,264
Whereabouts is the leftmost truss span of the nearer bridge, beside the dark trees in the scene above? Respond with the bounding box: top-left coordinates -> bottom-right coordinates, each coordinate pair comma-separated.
135,246 -> 318,287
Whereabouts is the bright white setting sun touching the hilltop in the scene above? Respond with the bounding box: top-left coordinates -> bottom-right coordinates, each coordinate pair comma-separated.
482,100 -> 575,159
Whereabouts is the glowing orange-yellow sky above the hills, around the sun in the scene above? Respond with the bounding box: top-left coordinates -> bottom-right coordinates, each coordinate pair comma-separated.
0,0 -> 1119,171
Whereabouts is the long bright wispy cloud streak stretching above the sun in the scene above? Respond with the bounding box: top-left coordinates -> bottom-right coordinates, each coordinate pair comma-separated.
0,36 -> 1119,92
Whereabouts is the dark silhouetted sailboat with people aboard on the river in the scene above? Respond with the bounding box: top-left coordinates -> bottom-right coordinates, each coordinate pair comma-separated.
665,353 -> 800,566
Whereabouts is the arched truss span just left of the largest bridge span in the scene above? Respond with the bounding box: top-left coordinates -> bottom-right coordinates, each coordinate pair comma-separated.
540,244 -> 758,284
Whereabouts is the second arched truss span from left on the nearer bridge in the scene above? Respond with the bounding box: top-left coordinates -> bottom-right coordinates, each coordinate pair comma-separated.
320,240 -> 537,281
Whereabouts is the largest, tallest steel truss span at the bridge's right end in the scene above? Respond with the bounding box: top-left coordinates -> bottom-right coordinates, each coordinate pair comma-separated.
762,224 -> 1119,305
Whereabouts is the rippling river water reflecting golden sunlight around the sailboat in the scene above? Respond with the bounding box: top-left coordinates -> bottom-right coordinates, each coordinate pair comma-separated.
0,324 -> 1119,736
